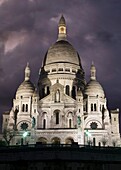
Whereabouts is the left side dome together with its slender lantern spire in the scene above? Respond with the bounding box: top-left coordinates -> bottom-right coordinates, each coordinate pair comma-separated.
16,63 -> 35,97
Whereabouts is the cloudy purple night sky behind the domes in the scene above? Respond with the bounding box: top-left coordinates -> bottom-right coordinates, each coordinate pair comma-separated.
0,0 -> 121,125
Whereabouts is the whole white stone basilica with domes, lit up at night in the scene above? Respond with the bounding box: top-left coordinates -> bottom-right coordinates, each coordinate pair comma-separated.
2,16 -> 120,146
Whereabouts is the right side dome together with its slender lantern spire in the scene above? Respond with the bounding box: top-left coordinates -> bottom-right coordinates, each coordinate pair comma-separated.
84,63 -> 105,98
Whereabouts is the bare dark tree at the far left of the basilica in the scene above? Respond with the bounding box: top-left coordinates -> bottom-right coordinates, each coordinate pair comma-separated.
3,129 -> 15,146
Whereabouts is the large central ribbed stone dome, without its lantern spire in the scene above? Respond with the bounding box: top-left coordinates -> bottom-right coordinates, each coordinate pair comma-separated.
44,40 -> 80,65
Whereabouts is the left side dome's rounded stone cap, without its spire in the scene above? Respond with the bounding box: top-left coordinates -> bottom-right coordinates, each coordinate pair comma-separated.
16,80 -> 35,96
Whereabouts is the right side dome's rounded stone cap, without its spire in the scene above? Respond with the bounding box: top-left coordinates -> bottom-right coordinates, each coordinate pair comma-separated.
84,80 -> 105,98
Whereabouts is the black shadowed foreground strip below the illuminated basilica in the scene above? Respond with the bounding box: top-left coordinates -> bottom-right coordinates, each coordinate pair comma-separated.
0,144 -> 121,170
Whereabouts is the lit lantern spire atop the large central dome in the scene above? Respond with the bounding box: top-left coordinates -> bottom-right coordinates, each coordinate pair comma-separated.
58,15 -> 67,41
